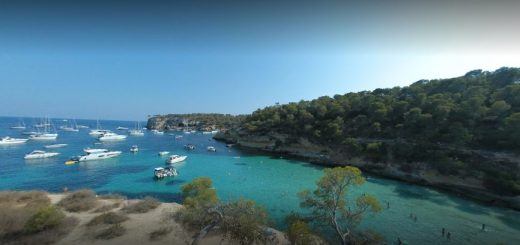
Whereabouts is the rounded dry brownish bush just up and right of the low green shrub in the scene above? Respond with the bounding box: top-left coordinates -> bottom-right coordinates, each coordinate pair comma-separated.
58,190 -> 97,212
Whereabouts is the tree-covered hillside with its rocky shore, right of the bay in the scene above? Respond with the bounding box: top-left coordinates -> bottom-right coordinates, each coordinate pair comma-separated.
210,68 -> 520,210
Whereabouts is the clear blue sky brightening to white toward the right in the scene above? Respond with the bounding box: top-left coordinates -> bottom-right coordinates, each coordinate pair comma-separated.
0,0 -> 520,120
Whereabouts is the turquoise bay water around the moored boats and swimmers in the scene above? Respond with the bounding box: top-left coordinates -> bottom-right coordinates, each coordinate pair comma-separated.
0,118 -> 520,244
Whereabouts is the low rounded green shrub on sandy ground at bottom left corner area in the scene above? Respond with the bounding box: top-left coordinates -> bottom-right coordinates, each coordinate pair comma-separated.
24,206 -> 65,233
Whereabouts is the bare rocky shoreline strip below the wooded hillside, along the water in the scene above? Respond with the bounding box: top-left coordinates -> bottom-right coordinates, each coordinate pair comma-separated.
214,131 -> 520,211
